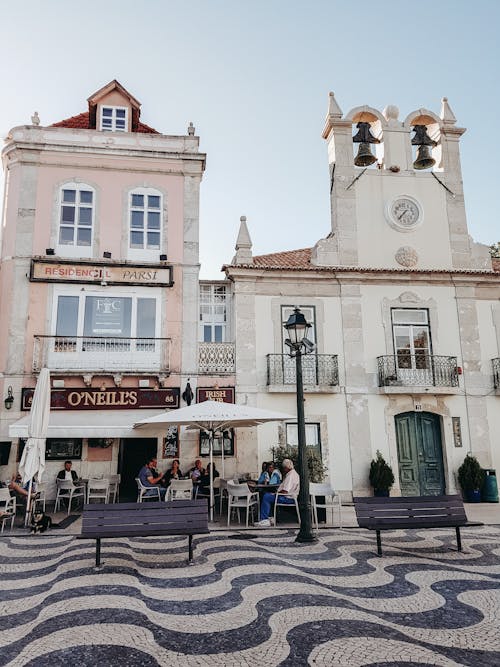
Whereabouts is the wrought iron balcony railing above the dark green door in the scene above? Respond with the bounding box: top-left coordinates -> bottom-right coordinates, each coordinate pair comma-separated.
377,352 -> 458,387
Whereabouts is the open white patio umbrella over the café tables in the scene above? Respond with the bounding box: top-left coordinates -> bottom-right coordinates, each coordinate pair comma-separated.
134,401 -> 294,521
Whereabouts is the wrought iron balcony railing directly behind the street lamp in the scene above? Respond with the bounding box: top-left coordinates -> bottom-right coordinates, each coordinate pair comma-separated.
267,354 -> 339,387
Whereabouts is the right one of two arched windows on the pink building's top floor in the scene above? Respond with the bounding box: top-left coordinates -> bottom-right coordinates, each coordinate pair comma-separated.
129,188 -> 163,250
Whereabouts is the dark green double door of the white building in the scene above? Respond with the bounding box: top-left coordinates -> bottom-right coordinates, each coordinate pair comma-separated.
395,412 -> 445,496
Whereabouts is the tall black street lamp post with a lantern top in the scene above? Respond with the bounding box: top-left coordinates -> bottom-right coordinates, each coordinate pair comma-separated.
284,308 -> 316,542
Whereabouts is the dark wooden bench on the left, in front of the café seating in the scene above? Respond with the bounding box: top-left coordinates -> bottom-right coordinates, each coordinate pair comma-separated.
78,500 -> 209,568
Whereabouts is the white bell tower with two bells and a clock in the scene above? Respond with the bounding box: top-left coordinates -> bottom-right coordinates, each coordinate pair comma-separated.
312,93 -> 491,270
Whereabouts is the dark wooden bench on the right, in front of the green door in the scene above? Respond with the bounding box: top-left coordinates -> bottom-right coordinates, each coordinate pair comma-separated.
353,495 -> 476,556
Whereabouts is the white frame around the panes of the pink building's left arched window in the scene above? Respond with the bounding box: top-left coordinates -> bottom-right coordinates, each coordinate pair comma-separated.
56,181 -> 96,257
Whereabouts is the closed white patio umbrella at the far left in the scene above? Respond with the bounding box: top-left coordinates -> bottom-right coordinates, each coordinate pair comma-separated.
19,368 -> 50,525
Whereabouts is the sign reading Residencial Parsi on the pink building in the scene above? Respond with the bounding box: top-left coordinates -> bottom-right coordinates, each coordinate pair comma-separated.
30,258 -> 174,287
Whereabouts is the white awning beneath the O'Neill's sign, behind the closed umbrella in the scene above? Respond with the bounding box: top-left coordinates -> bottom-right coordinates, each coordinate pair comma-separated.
9,410 -> 166,438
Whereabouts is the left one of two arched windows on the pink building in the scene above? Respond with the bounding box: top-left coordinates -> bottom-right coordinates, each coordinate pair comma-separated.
58,183 -> 95,248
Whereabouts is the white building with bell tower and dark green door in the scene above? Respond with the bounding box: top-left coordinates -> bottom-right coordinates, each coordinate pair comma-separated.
225,94 -> 500,497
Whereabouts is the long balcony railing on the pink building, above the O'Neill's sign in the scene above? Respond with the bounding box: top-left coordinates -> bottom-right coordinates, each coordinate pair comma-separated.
33,336 -> 170,373
